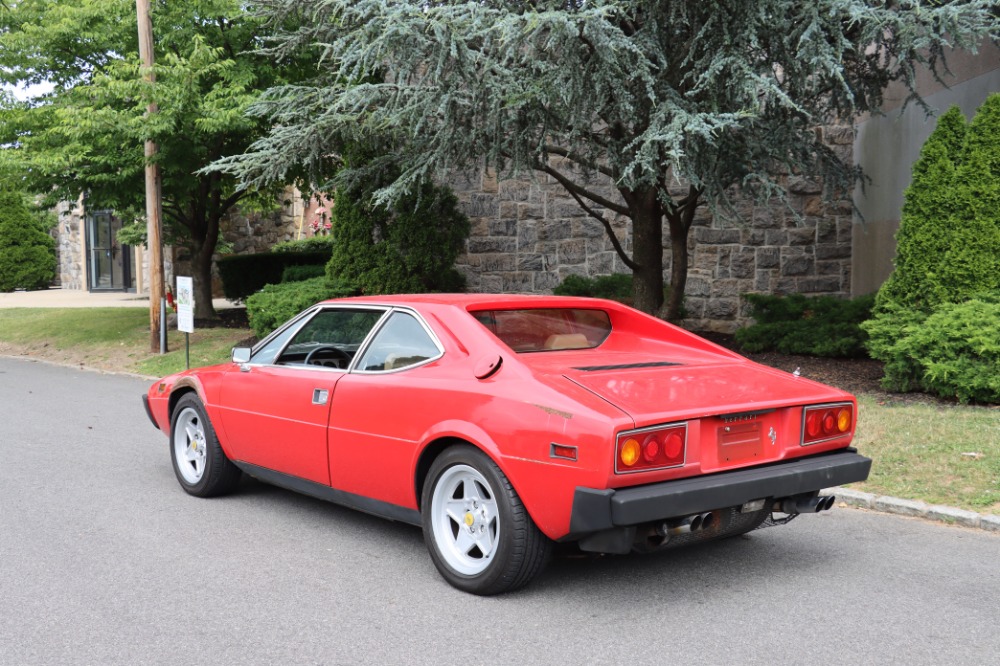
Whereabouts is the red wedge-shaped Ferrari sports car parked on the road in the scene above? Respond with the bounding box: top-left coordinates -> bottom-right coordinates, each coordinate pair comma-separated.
143,295 -> 871,594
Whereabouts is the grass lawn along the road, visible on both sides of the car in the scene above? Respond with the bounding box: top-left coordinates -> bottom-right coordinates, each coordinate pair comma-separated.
0,308 -> 1000,514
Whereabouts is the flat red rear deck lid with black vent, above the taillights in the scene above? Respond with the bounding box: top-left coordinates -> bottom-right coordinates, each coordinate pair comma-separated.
525,352 -> 849,424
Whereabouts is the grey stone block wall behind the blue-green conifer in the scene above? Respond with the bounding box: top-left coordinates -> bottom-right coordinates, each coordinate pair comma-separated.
449,127 -> 854,332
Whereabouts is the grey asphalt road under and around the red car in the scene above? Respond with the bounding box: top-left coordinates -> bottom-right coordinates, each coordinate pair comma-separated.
0,358 -> 1000,666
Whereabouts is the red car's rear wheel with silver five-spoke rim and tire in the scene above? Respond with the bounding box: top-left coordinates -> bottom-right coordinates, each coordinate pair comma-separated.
421,446 -> 551,595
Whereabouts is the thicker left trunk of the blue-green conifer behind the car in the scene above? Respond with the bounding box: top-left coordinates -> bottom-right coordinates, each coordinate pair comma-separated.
623,189 -> 663,315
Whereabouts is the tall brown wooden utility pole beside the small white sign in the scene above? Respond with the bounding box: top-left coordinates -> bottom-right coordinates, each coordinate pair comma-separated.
135,0 -> 167,354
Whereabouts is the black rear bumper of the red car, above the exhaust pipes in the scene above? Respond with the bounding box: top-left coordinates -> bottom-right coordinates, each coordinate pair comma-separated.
566,449 -> 872,539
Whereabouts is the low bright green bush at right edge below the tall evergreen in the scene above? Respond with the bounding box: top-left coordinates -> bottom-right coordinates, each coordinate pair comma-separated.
867,293 -> 1000,403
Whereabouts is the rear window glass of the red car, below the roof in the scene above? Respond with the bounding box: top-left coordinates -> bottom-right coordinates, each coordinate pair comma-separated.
472,308 -> 611,352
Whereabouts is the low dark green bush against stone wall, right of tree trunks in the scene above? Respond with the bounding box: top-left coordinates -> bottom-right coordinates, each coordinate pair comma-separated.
736,294 -> 875,358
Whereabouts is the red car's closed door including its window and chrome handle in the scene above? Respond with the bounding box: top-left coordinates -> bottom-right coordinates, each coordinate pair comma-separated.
220,307 -> 384,485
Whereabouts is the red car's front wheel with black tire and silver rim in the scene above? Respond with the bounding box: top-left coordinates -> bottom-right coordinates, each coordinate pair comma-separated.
170,393 -> 240,497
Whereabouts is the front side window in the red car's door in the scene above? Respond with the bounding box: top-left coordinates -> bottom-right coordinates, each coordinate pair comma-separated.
275,309 -> 383,368
